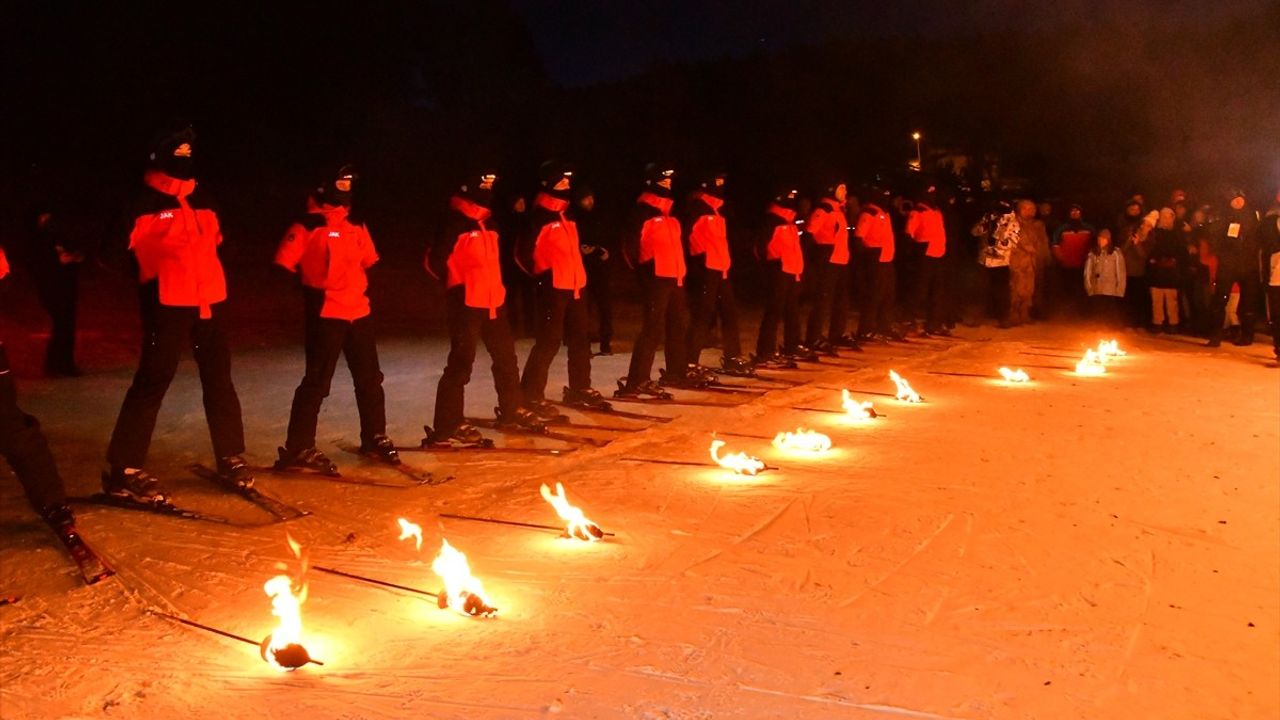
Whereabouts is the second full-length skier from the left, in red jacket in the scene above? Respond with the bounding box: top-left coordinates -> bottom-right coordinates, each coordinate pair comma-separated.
275,165 -> 399,473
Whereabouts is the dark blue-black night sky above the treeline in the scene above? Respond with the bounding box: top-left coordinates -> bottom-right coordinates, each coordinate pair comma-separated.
512,0 -> 1280,86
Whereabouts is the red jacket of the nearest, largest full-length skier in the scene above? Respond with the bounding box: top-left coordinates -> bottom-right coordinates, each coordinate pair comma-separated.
129,170 -> 227,319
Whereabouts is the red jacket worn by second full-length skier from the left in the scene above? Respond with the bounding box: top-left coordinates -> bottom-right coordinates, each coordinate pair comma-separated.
275,197 -> 378,320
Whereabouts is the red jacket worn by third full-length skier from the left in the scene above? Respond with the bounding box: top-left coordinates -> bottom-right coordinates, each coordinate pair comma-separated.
424,195 -> 507,320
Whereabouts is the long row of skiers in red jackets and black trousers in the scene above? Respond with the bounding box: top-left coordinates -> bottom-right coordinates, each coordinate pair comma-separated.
0,128 -> 1064,558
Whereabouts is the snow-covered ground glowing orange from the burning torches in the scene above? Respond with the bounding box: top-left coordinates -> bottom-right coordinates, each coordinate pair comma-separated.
0,320 -> 1280,720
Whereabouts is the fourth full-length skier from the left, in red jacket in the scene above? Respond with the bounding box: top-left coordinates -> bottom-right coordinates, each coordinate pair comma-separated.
517,161 -> 609,412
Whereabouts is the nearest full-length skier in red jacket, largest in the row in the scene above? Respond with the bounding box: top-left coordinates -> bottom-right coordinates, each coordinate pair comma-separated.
102,127 -> 253,501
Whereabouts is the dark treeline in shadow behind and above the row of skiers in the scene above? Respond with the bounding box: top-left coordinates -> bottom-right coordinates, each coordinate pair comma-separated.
3,0 -> 1280,257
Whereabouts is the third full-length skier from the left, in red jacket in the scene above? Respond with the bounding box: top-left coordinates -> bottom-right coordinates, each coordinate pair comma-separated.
424,172 -> 544,446
